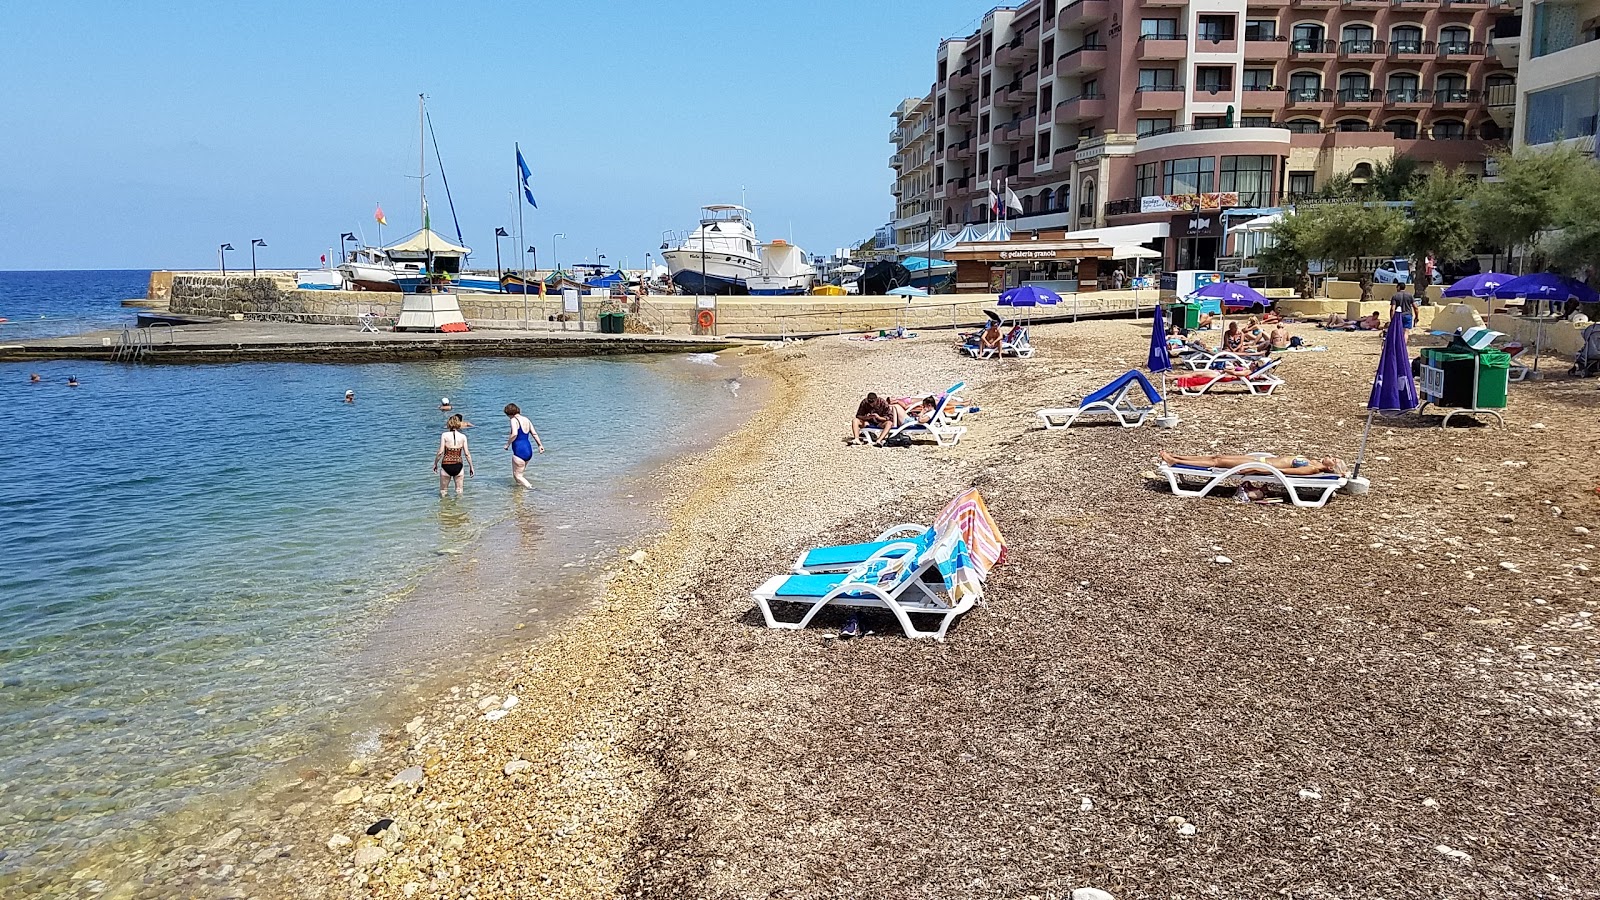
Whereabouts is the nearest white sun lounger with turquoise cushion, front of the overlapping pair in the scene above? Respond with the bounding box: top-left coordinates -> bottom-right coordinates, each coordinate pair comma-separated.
754,528 -> 982,641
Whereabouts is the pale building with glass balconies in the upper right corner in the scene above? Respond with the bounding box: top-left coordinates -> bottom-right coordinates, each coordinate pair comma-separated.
1488,0 -> 1600,152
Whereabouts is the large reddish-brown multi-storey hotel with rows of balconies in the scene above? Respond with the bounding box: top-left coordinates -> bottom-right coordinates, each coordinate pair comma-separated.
931,0 -> 1504,269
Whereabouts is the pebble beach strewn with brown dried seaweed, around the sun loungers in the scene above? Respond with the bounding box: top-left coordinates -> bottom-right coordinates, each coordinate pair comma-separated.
112,320 -> 1600,900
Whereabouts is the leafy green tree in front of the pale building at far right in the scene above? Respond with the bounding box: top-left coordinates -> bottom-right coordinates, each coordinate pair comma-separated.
1472,146 -> 1594,267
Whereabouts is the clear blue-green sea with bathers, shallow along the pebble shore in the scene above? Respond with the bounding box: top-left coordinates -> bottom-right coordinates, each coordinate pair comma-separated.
0,271 -> 752,895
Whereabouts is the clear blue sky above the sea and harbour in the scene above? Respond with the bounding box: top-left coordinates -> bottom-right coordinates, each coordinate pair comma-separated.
0,0 -> 987,269
